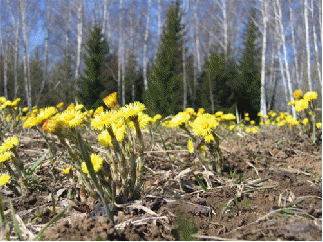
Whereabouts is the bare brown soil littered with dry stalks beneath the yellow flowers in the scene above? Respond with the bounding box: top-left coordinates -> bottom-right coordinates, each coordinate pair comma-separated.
4,128 -> 322,241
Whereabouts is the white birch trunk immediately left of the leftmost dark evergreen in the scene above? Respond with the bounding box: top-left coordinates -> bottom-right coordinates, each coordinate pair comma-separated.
75,1 -> 83,80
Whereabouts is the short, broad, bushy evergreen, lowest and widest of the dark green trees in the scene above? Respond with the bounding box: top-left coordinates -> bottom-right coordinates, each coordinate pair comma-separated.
197,47 -> 238,113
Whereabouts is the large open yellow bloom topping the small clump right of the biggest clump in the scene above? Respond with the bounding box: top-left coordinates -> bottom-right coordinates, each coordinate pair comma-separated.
191,113 -> 219,136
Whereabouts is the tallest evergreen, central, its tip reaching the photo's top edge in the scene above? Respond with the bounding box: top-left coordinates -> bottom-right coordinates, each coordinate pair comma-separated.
145,1 -> 184,115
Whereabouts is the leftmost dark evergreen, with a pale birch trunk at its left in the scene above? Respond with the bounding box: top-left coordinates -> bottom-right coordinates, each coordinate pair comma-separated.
78,26 -> 109,109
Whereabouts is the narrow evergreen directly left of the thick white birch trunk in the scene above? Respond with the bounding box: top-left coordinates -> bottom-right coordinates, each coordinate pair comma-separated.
236,9 -> 261,119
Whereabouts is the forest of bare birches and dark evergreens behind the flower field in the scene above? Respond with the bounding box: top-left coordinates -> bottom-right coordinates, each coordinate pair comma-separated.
0,0 -> 322,118
